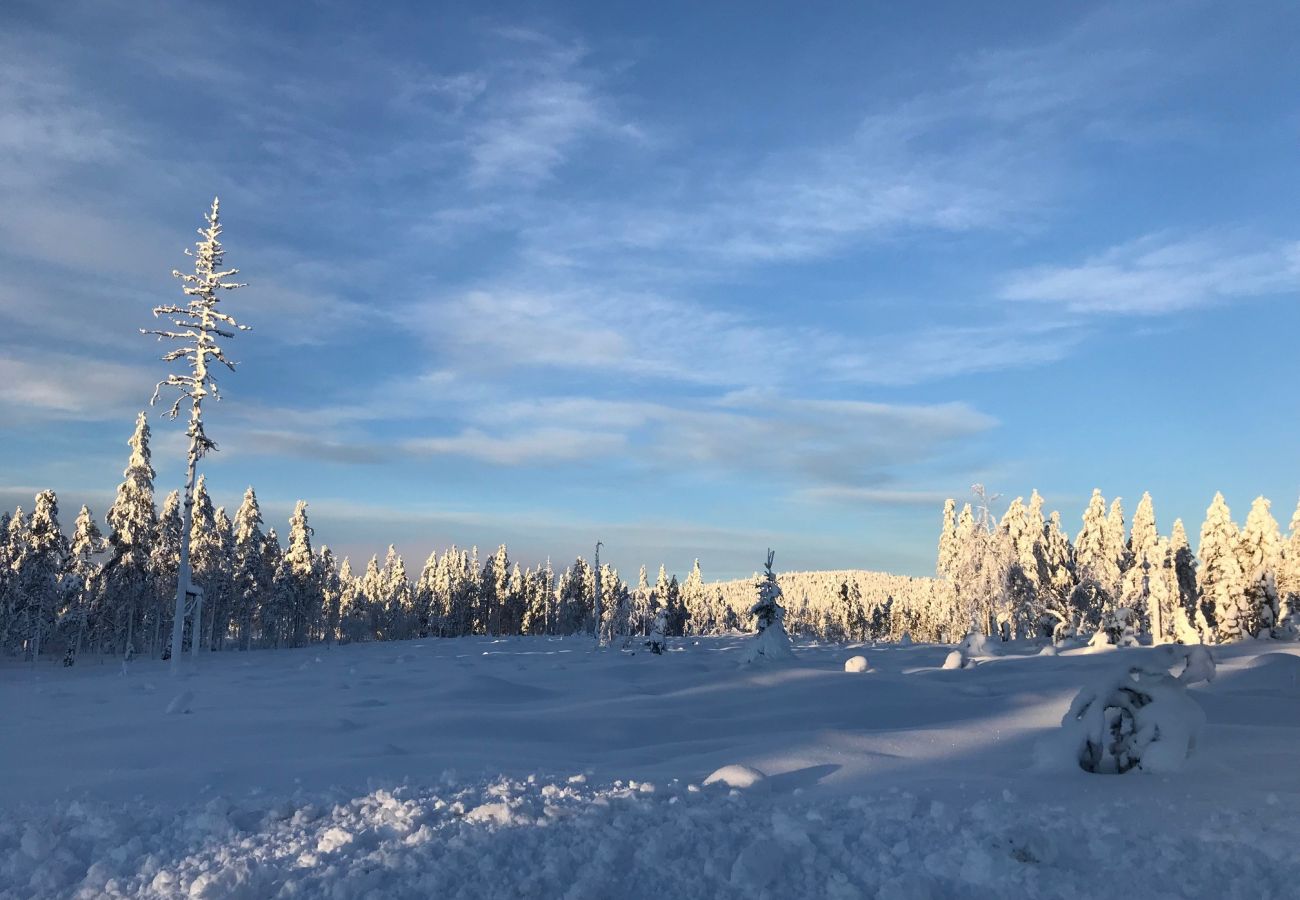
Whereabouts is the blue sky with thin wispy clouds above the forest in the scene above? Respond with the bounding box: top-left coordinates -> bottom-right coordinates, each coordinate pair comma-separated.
0,0 -> 1300,577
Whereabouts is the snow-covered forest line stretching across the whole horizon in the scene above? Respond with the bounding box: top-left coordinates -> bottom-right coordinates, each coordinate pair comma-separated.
0,412 -> 1300,662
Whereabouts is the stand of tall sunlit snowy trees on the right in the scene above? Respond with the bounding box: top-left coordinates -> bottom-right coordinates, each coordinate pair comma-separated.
920,485 -> 1300,644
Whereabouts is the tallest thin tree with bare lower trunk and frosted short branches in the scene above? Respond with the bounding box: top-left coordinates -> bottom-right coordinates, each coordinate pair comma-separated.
140,198 -> 248,672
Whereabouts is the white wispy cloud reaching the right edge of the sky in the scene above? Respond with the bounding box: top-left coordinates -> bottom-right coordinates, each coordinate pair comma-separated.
1001,234 -> 1300,316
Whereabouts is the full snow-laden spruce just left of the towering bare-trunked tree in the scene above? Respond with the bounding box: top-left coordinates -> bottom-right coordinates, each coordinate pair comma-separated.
102,412 -> 159,653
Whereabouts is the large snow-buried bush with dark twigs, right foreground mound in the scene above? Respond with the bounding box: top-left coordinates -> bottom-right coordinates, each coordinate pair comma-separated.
1037,645 -> 1214,775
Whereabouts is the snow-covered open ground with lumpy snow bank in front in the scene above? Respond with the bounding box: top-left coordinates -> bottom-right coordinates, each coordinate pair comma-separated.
0,637 -> 1300,899
